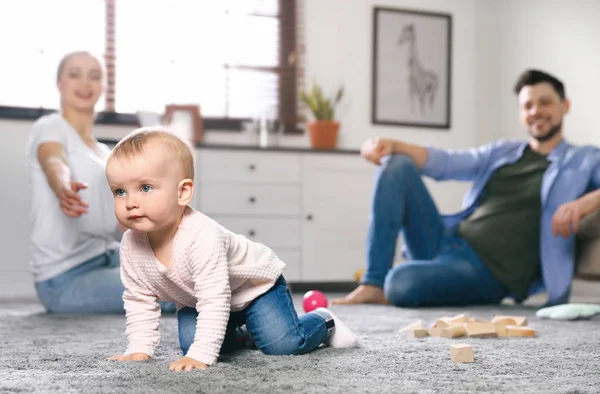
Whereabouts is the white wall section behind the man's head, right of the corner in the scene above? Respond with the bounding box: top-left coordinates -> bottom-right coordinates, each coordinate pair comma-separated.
476,0 -> 600,145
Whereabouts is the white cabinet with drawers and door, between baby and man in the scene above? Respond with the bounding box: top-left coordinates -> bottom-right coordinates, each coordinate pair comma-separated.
193,147 -> 375,282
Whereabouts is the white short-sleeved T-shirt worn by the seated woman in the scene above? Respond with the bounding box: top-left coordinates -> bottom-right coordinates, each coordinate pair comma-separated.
26,113 -> 120,282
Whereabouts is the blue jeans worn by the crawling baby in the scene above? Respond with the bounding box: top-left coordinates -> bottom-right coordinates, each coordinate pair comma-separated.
177,276 -> 328,355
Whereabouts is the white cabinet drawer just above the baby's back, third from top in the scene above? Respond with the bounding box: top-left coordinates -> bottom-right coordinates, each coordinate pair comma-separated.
212,215 -> 301,249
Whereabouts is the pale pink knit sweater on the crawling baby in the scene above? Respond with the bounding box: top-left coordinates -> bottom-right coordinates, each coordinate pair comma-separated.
121,207 -> 285,365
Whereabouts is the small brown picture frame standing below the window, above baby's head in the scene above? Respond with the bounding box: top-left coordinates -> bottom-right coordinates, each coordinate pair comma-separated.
163,104 -> 204,144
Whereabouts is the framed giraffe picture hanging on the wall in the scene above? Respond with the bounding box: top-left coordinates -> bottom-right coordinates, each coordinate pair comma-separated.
371,7 -> 452,129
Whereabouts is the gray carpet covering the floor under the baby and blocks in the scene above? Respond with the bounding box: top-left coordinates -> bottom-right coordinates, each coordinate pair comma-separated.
0,298 -> 600,394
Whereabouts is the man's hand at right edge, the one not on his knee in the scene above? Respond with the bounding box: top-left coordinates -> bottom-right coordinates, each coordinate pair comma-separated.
552,193 -> 600,238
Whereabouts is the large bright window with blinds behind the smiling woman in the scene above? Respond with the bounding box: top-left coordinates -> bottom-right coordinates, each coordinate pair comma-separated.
0,0 -> 298,132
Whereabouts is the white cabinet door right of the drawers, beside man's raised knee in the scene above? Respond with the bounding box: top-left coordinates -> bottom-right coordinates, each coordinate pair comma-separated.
302,154 -> 375,282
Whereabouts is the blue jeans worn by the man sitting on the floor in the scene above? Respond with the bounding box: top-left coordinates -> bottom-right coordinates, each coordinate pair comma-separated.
361,155 -> 507,307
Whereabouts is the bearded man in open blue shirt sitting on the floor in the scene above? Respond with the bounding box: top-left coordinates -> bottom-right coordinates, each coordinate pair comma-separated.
333,70 -> 600,307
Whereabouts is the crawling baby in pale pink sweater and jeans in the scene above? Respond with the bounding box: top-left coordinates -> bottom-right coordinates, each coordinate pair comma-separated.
106,128 -> 358,371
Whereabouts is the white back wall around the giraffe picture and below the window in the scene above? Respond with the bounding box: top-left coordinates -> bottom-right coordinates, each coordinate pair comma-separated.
0,0 -> 479,299
